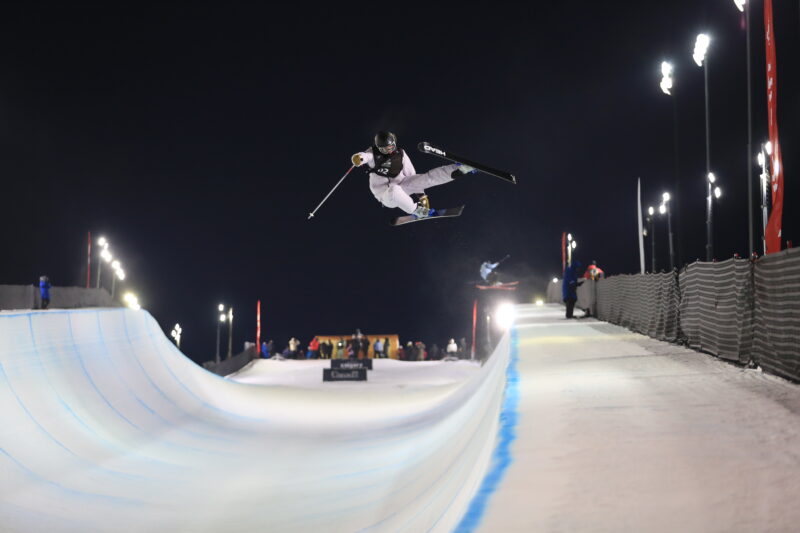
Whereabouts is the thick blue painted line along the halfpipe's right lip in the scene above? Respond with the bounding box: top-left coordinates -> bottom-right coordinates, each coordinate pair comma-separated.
454,327 -> 519,533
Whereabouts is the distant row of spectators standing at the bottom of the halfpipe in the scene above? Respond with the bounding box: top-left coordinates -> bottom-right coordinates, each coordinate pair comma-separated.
261,330 -> 476,361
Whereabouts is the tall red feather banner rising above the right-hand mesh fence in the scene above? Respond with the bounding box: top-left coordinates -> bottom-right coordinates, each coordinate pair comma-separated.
764,0 -> 783,254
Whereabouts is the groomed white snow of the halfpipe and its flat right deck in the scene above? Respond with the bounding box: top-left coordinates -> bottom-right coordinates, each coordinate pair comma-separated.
0,306 -> 800,532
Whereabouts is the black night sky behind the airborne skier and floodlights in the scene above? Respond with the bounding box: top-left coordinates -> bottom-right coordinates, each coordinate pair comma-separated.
0,0 -> 800,361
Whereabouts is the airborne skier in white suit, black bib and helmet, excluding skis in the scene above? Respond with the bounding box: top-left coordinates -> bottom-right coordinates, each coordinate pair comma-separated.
351,131 -> 476,218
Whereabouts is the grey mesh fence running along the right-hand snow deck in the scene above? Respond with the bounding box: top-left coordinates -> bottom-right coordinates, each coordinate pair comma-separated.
580,248 -> 800,381
